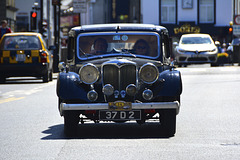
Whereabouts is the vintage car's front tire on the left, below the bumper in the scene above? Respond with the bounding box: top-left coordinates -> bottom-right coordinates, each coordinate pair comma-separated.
64,111 -> 80,137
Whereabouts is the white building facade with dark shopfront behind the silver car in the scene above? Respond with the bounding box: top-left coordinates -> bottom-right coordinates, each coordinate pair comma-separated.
141,0 -> 234,42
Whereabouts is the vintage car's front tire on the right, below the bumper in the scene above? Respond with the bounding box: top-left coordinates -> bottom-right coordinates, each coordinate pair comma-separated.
160,109 -> 176,137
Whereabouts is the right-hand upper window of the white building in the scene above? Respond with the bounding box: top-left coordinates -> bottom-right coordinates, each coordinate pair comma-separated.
199,0 -> 214,23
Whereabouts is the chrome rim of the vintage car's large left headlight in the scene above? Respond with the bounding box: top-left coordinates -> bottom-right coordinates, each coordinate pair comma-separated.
78,63 -> 100,84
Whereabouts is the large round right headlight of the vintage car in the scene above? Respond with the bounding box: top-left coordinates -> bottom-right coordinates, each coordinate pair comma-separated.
139,63 -> 159,84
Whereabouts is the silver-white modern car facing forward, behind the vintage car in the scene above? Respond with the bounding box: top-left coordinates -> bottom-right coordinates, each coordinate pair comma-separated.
175,34 -> 218,66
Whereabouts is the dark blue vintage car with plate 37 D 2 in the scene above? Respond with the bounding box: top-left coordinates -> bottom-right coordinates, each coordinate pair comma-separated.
57,24 -> 182,136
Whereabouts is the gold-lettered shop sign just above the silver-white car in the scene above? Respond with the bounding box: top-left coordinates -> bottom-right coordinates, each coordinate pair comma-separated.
174,24 -> 200,34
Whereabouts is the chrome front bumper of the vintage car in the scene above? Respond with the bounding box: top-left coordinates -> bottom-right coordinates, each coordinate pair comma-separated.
60,101 -> 180,115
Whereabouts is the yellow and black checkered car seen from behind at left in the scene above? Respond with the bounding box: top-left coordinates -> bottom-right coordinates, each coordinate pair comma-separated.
0,32 -> 53,83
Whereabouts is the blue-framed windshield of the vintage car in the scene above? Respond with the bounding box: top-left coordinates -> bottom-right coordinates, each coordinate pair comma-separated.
77,32 -> 160,59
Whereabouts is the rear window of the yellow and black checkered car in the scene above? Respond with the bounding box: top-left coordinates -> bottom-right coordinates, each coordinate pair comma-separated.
1,35 -> 42,50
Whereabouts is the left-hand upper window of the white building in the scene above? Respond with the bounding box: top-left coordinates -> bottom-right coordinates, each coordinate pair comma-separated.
161,0 -> 176,23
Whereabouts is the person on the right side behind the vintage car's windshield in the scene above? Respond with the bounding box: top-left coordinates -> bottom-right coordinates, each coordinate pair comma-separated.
133,39 -> 150,55
